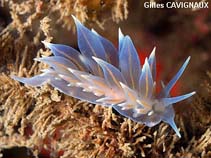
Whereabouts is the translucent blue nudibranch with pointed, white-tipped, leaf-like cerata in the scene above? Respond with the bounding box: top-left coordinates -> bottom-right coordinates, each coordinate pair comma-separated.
12,16 -> 195,137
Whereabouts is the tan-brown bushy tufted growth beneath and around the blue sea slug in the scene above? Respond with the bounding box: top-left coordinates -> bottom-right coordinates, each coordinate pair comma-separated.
0,0 -> 211,158
